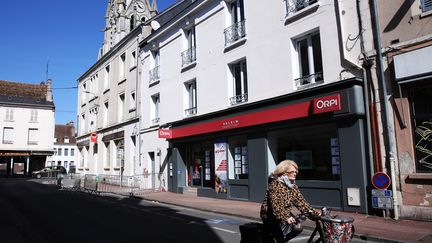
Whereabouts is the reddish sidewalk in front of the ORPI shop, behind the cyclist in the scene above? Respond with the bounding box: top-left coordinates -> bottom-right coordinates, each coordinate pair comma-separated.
136,192 -> 432,242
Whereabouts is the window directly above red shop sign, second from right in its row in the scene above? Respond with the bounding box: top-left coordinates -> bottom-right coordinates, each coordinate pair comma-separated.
230,60 -> 248,105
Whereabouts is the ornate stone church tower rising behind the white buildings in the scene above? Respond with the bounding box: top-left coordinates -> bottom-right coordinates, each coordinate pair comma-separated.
99,0 -> 157,58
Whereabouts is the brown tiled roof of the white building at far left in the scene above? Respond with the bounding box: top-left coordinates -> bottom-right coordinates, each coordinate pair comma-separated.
0,80 -> 54,107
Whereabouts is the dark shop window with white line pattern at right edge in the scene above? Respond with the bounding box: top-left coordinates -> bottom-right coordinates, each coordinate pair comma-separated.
411,86 -> 432,173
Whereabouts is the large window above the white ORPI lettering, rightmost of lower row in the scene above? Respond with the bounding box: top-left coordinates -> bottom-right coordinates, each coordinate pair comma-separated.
295,33 -> 323,87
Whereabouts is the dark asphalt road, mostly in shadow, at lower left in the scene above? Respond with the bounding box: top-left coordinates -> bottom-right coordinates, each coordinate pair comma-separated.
0,178 -> 370,243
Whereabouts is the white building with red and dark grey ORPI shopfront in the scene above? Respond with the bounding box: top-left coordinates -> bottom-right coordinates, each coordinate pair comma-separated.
137,0 -> 369,212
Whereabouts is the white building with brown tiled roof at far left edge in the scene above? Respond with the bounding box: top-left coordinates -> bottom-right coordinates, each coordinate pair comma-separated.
0,80 -> 55,176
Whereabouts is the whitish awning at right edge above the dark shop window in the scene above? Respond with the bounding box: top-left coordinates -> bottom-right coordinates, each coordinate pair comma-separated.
393,46 -> 432,84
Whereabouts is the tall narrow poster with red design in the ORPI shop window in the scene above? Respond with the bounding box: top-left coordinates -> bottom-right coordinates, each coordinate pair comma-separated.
214,143 -> 228,193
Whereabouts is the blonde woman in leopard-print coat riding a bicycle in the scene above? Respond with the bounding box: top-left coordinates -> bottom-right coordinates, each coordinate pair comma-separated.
260,160 -> 321,242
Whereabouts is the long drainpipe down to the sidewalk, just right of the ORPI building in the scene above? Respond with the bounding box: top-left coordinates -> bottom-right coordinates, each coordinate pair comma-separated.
370,0 -> 399,220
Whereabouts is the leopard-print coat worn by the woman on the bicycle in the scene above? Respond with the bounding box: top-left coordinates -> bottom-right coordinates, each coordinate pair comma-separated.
260,179 -> 319,224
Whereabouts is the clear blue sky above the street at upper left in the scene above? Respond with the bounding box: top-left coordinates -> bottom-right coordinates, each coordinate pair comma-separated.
0,0 -> 176,124
